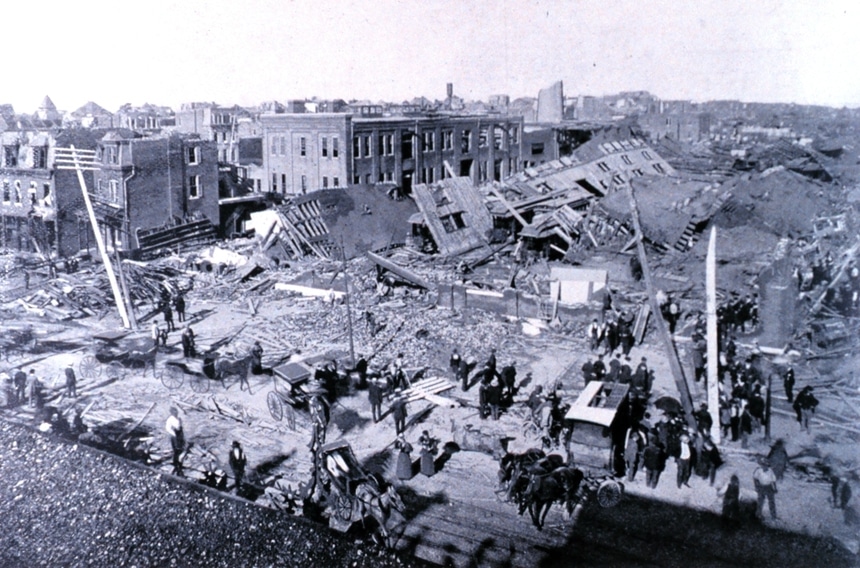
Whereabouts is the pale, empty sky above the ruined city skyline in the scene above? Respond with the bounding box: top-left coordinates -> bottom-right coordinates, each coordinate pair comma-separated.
6,0 -> 860,112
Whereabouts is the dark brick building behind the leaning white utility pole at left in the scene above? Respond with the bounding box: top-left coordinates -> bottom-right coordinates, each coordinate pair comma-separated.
91,130 -> 219,250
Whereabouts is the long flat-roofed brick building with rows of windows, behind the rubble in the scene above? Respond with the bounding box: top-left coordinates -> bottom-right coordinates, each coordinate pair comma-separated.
255,112 -> 523,195
